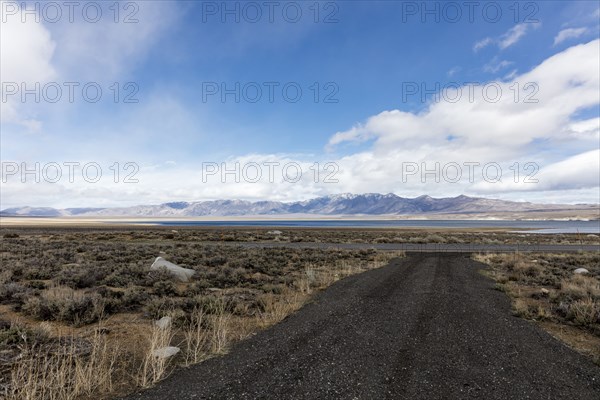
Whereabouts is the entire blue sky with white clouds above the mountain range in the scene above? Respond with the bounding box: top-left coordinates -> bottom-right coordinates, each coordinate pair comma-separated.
0,1 -> 600,207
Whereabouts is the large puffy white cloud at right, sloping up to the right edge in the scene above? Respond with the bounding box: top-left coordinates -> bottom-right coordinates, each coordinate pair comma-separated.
329,40 -> 600,198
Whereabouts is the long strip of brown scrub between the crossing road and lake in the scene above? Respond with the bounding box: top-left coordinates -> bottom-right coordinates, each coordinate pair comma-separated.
2,226 -> 600,245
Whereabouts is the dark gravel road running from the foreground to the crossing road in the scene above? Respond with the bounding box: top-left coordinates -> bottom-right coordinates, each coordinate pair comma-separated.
129,253 -> 600,400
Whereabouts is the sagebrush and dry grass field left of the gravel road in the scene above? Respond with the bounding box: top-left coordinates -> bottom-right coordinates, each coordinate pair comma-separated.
0,228 -> 402,400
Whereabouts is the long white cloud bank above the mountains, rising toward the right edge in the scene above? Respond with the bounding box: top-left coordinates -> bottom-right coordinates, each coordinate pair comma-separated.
1,30 -> 600,208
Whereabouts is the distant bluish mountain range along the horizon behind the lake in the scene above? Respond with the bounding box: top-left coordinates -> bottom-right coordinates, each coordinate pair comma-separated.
0,193 -> 598,217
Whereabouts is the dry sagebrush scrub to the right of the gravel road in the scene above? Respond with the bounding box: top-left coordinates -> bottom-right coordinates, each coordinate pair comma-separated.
474,252 -> 600,365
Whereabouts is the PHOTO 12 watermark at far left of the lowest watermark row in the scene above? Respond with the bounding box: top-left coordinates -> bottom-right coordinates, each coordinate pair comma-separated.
1,161 -> 140,184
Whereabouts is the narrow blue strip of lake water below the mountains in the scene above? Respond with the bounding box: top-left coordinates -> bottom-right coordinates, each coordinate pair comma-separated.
127,219 -> 600,234
